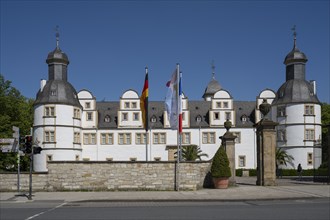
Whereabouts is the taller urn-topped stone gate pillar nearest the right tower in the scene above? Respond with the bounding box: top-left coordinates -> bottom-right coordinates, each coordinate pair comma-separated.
255,99 -> 278,186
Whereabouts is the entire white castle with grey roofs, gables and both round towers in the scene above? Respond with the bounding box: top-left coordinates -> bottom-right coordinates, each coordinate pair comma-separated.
33,34 -> 321,171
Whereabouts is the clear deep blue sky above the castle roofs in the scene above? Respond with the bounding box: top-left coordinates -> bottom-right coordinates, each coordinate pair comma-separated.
0,0 -> 330,103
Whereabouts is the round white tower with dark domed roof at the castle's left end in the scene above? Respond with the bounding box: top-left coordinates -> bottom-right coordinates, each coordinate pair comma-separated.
33,32 -> 82,171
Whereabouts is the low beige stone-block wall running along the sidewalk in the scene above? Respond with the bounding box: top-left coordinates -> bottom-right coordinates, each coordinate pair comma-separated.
0,161 -> 210,191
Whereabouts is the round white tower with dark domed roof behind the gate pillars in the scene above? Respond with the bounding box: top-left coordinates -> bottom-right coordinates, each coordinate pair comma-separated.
272,29 -> 322,169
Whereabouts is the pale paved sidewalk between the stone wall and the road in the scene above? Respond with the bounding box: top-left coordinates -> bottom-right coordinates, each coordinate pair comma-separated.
0,177 -> 330,202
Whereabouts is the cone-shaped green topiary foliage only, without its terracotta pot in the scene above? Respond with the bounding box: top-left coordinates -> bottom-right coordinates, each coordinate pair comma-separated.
211,145 -> 231,178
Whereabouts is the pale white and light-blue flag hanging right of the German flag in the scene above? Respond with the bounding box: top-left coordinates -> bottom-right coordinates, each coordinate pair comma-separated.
165,65 -> 182,130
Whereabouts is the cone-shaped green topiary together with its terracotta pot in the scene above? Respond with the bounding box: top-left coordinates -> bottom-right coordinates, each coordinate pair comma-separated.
211,145 -> 231,189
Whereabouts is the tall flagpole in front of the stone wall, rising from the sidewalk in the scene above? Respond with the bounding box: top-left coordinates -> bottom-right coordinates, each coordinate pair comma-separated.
176,63 -> 181,191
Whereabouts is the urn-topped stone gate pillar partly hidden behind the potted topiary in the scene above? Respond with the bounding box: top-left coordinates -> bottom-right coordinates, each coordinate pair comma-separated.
219,119 -> 237,185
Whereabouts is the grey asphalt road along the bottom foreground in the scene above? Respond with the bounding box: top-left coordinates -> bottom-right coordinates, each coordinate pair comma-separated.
0,198 -> 330,220
